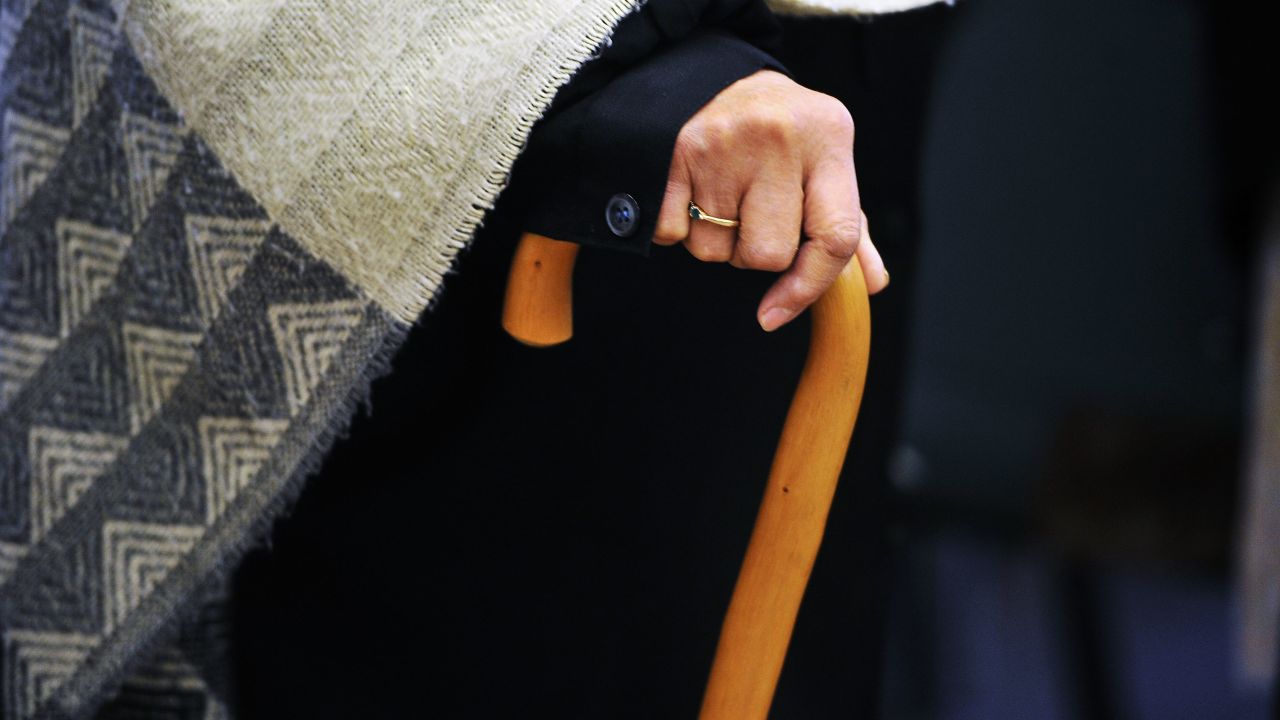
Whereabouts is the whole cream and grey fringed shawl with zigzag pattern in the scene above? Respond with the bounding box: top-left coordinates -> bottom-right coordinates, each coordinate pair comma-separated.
0,0 -> 942,719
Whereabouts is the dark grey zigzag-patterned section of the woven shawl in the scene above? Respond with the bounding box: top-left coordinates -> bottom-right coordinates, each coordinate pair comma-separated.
0,0 -> 404,719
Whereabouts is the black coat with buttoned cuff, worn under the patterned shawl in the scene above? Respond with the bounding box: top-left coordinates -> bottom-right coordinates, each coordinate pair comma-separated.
234,0 -> 942,719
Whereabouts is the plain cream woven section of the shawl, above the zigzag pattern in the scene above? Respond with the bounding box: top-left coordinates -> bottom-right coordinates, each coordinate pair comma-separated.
127,0 -> 952,322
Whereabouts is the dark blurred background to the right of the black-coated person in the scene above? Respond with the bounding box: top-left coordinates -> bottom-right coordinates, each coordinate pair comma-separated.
855,0 -> 1280,720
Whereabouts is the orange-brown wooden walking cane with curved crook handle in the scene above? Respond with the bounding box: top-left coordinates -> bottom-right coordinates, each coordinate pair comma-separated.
502,217 -> 870,720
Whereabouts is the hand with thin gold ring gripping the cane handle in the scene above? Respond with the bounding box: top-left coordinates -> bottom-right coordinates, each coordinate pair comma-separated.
654,70 -> 888,331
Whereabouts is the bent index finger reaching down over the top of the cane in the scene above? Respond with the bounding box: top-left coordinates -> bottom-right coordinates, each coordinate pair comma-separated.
756,154 -> 865,332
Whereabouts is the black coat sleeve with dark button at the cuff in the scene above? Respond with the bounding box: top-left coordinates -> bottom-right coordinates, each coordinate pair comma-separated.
512,0 -> 785,254
